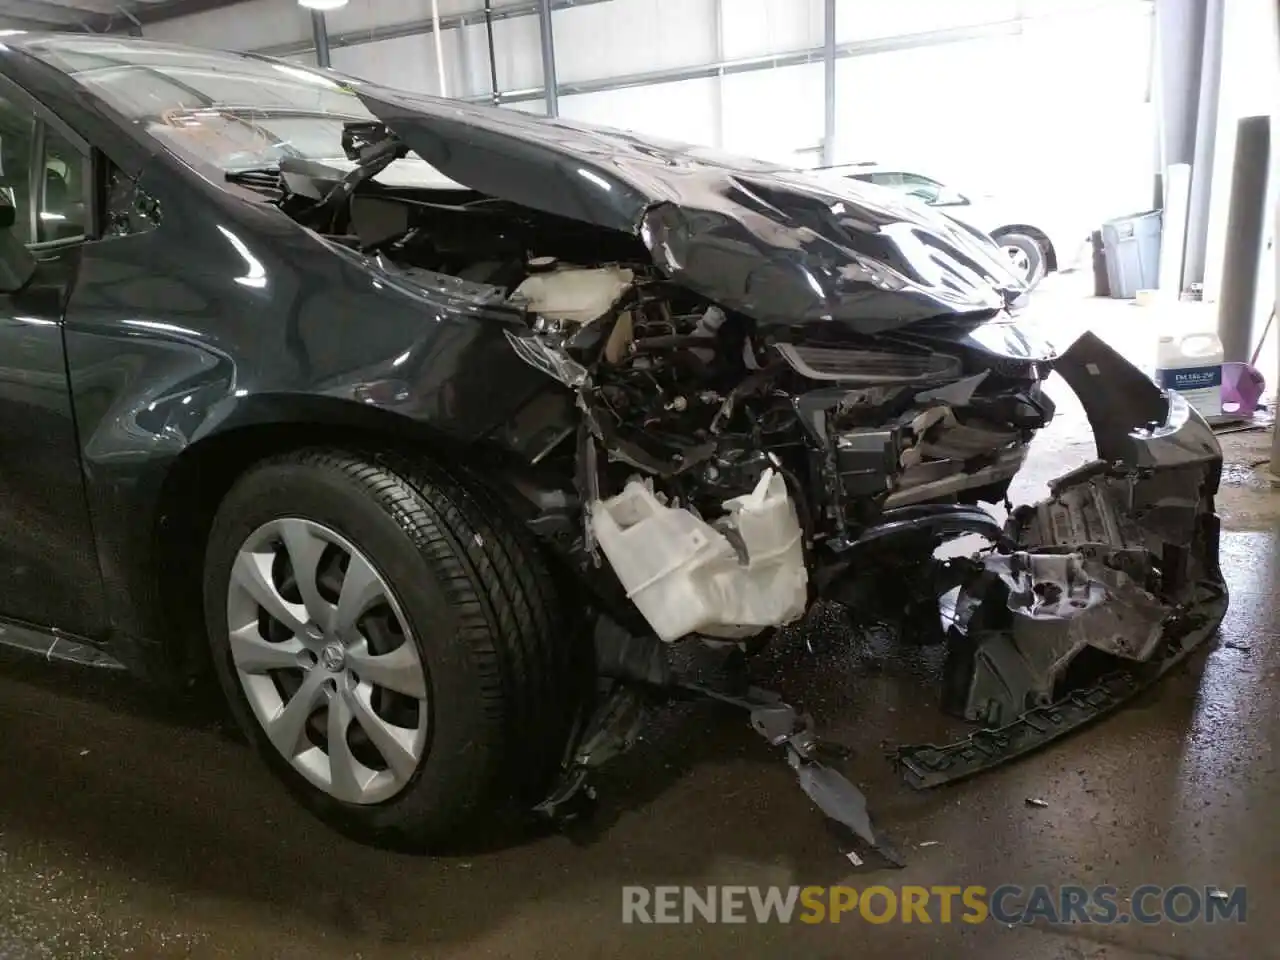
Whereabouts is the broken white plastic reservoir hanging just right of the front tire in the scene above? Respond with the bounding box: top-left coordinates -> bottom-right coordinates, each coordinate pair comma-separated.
591,470 -> 809,643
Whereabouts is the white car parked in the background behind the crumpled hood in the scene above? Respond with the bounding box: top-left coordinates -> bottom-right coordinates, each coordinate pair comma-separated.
815,163 -> 1088,287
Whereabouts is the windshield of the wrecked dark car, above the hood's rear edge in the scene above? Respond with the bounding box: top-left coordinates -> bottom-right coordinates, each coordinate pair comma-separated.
12,35 -> 452,183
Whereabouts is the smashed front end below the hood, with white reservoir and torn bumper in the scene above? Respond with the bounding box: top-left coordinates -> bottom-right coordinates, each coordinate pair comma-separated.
494,256 -> 1226,849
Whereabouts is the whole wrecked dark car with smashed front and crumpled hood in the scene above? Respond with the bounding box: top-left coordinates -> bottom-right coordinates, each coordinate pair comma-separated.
0,32 -> 1226,851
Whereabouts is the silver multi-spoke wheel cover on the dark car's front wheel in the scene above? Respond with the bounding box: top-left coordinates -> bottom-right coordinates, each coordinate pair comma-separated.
227,518 -> 429,804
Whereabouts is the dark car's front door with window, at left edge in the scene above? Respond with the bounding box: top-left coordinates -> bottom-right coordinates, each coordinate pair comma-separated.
0,81 -> 104,639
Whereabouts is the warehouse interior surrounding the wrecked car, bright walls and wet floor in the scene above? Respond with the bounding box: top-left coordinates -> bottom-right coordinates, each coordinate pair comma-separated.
0,0 -> 1280,960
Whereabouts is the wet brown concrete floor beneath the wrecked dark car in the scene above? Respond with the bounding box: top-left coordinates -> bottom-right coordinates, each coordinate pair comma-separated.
0,278 -> 1280,960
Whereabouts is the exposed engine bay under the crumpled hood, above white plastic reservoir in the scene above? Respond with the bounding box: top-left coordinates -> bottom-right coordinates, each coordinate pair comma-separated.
241,134 -> 1053,563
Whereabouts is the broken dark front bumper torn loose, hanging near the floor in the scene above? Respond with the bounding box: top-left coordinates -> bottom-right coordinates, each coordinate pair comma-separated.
895,334 -> 1228,787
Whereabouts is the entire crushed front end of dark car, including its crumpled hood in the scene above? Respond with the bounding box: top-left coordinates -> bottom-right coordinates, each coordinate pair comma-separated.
278,99 -> 1226,851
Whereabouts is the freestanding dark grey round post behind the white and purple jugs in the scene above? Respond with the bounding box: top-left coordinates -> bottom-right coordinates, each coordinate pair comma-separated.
1217,115 -> 1271,362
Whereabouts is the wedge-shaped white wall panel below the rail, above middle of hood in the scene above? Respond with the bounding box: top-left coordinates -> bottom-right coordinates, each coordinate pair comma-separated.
559,78 -> 718,146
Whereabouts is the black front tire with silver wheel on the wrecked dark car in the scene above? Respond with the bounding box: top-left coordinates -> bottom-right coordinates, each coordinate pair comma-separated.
204,449 -> 581,850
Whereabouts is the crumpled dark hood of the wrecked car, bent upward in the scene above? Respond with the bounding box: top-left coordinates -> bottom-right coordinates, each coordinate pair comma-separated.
355,83 -> 1025,333
